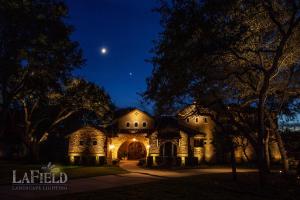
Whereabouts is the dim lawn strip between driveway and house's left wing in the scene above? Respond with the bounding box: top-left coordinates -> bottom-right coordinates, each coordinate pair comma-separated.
0,161 -> 127,185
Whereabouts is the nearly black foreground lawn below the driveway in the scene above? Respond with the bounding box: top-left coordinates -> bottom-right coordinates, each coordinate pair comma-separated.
55,173 -> 300,200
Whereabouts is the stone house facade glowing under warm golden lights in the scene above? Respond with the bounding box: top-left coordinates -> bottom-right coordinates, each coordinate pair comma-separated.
68,106 -> 280,165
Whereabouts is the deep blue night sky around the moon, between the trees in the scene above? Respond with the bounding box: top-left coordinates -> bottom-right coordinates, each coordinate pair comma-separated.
67,0 -> 161,109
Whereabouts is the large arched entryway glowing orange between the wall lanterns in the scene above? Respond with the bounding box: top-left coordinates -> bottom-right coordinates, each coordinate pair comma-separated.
118,141 -> 147,160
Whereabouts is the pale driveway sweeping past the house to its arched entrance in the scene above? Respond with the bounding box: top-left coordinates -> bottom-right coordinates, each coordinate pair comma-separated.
0,161 -> 255,200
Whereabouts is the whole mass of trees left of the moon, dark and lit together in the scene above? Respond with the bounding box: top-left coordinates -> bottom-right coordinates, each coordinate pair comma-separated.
0,0 -> 113,161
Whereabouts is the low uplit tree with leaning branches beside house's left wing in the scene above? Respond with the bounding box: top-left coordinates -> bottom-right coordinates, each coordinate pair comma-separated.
19,79 -> 114,160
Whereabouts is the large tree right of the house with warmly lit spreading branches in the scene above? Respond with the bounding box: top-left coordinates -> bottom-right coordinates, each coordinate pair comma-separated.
144,0 -> 300,183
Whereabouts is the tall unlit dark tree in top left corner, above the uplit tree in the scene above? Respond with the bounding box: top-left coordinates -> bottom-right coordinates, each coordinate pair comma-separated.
0,0 -> 84,135
